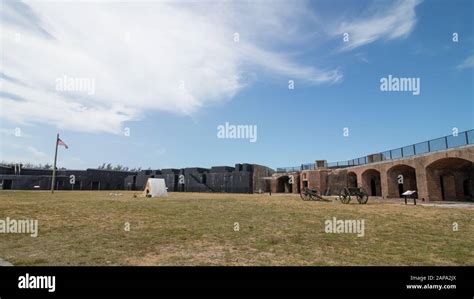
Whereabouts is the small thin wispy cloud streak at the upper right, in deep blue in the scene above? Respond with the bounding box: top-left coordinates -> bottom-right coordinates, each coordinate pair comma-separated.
332,0 -> 422,51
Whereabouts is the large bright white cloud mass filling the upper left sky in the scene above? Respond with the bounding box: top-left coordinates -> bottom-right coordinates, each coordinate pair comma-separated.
0,1 -> 342,133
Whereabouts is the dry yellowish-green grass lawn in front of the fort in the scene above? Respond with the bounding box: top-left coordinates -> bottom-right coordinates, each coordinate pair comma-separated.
0,191 -> 474,265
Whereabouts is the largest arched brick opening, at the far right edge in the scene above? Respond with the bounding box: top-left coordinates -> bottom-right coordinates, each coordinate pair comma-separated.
426,158 -> 474,201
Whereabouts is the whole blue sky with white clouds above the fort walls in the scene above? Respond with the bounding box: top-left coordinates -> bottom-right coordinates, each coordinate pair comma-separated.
0,0 -> 474,169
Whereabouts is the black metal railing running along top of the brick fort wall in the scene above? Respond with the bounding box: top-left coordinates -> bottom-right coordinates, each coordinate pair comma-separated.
277,129 -> 474,172
